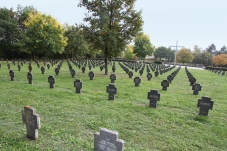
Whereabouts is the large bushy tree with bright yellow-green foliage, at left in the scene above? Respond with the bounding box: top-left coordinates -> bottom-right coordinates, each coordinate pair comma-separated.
20,13 -> 67,58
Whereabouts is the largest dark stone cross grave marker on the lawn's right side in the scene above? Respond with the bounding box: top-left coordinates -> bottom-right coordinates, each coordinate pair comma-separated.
197,97 -> 214,116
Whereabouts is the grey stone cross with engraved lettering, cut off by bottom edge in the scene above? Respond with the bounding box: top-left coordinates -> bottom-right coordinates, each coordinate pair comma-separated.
94,128 -> 124,151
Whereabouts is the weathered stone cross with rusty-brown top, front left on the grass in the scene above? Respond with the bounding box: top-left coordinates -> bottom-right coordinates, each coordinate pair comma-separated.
22,106 -> 41,140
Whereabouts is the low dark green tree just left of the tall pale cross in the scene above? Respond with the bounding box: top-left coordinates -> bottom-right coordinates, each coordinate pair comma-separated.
154,46 -> 175,61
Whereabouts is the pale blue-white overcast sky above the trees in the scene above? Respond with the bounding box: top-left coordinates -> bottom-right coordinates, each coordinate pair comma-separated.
0,0 -> 227,50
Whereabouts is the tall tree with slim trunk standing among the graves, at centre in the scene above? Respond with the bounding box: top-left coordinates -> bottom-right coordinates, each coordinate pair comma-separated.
78,0 -> 143,75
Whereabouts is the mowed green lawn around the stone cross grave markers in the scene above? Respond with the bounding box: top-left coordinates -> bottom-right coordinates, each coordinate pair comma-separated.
0,61 -> 227,151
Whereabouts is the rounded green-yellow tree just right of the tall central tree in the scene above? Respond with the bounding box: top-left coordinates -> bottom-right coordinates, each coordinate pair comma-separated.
134,33 -> 154,58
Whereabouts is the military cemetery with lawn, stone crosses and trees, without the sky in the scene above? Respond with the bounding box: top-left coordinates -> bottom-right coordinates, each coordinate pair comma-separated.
0,0 -> 227,151
